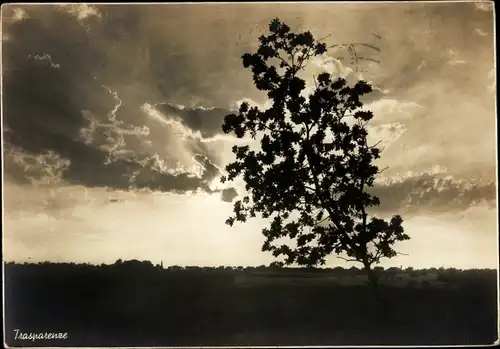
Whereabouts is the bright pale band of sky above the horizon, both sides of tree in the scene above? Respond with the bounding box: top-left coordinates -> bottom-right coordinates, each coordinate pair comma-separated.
4,178 -> 496,268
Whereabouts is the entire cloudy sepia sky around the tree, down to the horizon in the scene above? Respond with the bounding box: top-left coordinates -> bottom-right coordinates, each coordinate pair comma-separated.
2,2 -> 498,269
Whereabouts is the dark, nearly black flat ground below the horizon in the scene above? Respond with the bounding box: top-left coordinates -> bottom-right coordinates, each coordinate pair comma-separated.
5,263 -> 498,347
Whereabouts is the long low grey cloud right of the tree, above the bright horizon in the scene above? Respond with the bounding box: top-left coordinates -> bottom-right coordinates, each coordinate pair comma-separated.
370,172 -> 497,216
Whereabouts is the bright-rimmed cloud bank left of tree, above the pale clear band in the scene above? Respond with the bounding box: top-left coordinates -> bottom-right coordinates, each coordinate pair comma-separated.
5,70 -> 229,198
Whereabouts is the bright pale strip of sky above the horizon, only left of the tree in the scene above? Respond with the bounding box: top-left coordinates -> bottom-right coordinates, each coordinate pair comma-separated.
4,182 -> 267,266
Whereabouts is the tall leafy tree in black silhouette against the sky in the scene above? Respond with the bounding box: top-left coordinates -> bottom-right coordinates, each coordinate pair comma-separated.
222,18 -> 409,288
